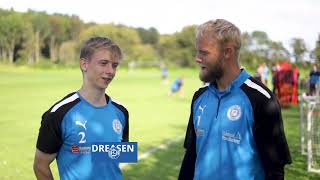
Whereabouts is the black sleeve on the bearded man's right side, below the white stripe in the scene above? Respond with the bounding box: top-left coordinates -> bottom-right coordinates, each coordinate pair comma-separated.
253,93 -> 291,180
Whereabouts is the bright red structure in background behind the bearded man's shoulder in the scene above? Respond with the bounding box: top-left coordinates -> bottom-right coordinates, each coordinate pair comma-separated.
275,61 -> 299,107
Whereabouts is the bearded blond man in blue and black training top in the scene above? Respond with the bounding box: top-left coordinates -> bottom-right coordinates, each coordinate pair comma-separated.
179,19 -> 291,180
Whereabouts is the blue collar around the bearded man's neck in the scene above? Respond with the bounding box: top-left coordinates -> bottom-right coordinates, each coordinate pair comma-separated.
209,69 -> 250,97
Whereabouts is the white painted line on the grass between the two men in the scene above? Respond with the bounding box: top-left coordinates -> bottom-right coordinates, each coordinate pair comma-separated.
120,136 -> 184,169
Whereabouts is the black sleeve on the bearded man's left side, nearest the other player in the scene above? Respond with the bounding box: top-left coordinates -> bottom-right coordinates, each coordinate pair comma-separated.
178,87 -> 207,180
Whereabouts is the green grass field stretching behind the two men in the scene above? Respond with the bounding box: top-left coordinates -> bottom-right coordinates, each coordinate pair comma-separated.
0,65 -> 320,180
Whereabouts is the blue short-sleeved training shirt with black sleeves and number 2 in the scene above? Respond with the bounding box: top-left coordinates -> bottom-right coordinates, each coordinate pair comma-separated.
37,92 -> 129,180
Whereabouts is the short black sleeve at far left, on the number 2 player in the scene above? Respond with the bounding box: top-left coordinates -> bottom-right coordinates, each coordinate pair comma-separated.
37,111 -> 62,154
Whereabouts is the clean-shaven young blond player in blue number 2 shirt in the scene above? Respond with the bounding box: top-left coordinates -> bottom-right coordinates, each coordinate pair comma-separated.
34,37 -> 129,180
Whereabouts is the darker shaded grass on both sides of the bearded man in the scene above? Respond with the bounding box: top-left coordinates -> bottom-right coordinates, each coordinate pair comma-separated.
123,106 -> 320,180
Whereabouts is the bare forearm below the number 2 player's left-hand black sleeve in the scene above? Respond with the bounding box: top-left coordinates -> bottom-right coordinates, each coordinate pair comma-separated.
33,149 -> 57,180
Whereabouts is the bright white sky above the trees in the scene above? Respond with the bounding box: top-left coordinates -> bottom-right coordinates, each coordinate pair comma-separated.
0,0 -> 320,50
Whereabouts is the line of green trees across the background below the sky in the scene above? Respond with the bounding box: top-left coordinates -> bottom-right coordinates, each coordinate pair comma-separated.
0,9 -> 320,67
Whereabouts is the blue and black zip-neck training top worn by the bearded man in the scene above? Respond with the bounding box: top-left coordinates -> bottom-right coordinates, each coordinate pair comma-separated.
179,70 -> 291,180
